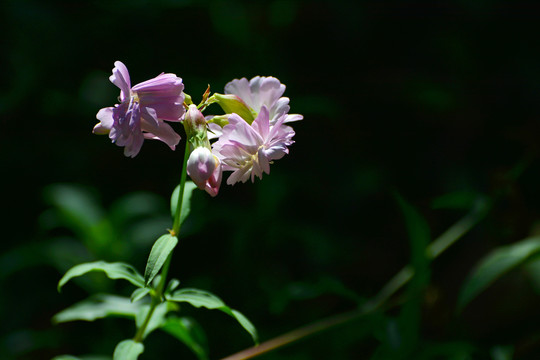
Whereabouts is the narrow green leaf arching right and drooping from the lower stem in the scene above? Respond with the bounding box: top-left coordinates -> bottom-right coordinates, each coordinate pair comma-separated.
168,288 -> 258,343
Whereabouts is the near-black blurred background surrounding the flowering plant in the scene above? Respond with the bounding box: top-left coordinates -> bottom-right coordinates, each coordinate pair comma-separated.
0,0 -> 540,359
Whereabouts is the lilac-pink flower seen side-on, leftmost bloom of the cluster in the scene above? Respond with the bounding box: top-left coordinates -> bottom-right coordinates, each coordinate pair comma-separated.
93,61 -> 184,157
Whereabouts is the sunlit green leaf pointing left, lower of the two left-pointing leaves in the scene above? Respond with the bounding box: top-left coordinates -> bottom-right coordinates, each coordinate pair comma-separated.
53,294 -> 141,323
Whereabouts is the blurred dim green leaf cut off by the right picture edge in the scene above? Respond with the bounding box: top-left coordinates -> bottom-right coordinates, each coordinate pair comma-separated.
458,237 -> 540,310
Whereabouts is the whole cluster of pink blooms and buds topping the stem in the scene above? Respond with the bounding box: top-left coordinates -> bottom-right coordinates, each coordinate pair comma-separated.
94,61 -> 303,196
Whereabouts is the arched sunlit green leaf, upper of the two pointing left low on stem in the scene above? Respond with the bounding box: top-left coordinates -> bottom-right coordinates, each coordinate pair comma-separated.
58,261 -> 144,291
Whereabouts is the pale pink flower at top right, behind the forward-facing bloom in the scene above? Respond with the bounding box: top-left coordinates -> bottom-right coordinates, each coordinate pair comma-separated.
225,76 -> 304,125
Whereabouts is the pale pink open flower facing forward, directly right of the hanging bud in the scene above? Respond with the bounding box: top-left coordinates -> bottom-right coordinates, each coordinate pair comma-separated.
212,105 -> 294,185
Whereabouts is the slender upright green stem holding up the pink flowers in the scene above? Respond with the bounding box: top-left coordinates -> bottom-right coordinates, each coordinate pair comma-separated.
133,141 -> 189,342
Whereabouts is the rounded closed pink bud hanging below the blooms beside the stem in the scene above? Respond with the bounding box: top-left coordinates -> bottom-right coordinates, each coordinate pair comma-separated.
186,147 -> 222,196
